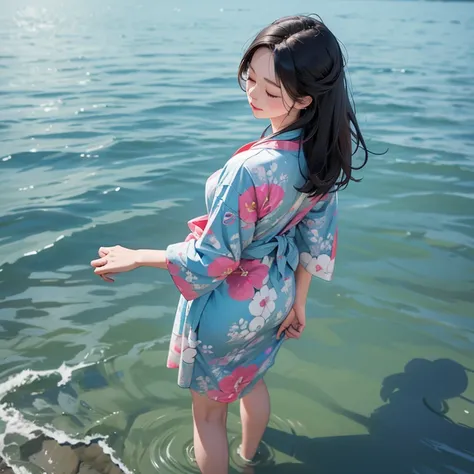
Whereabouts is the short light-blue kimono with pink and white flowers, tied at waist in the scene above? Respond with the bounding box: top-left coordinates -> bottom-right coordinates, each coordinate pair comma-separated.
166,131 -> 337,403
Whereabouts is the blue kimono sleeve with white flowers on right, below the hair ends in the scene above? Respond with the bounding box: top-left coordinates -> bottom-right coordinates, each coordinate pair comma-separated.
296,192 -> 337,281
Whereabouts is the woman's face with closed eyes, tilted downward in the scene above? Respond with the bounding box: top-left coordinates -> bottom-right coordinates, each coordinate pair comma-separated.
245,47 -> 306,132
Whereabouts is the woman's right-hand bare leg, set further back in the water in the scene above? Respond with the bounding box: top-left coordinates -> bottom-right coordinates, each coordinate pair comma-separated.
240,379 -> 270,460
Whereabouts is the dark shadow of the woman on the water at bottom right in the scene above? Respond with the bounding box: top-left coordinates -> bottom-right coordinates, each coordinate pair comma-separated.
254,359 -> 474,474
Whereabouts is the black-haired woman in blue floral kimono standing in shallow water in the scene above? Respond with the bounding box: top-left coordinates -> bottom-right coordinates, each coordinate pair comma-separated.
92,16 -> 368,474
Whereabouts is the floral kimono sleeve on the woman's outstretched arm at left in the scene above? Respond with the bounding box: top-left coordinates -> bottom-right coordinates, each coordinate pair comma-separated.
166,166 -> 255,301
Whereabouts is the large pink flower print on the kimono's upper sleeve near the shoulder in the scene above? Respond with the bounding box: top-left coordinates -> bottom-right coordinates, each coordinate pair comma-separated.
239,184 -> 285,222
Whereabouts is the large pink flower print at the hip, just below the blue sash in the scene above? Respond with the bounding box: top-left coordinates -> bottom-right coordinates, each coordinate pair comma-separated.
226,260 -> 269,301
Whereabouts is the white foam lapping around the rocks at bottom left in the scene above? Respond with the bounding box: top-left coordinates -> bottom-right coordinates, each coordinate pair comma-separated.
0,362 -> 133,474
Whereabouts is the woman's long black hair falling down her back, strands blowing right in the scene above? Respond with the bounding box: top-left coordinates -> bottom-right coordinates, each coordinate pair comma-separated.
238,16 -> 369,196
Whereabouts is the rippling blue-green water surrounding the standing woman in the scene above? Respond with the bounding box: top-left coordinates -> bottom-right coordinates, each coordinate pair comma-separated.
0,0 -> 474,474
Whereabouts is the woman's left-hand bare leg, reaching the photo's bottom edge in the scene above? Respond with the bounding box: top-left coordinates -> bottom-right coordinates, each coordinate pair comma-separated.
191,390 -> 229,474
